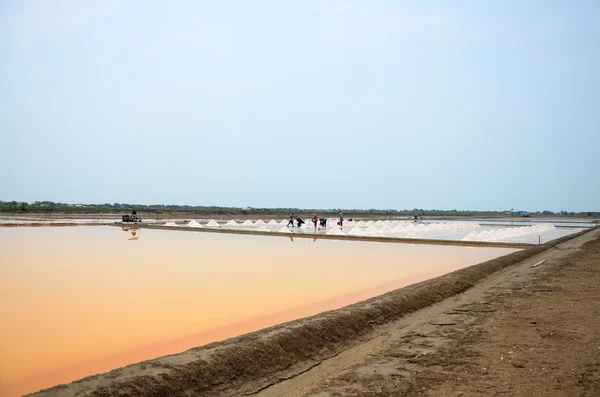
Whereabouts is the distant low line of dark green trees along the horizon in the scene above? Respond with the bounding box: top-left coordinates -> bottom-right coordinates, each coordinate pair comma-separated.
0,201 -> 600,217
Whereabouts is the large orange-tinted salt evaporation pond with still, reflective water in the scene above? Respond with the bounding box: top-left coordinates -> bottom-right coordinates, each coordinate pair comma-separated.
0,226 -> 515,397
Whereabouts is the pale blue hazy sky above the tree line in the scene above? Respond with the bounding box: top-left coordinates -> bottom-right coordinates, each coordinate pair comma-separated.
0,0 -> 600,211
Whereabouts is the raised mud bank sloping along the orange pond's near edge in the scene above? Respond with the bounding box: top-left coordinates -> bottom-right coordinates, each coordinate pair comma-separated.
28,230 -> 588,397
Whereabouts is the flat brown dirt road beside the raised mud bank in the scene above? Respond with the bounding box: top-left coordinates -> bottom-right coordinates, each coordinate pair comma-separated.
256,230 -> 600,397
